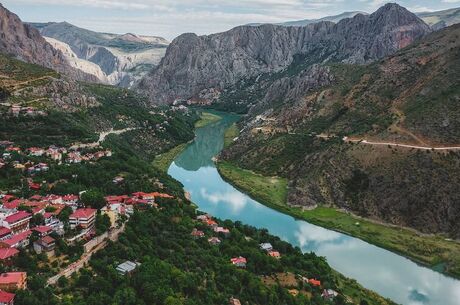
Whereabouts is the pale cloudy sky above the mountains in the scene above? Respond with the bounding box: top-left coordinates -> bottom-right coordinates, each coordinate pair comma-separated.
0,0 -> 460,40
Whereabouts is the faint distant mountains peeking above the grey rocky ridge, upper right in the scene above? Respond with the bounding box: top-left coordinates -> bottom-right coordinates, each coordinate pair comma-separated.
249,8 -> 460,30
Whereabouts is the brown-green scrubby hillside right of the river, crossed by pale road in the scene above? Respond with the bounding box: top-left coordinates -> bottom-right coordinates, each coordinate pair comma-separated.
221,25 -> 460,238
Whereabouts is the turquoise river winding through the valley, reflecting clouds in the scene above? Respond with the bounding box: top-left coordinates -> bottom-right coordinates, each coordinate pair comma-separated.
168,114 -> 460,305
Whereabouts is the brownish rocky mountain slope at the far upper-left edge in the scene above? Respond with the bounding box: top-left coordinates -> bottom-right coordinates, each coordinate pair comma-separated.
0,4 -> 97,81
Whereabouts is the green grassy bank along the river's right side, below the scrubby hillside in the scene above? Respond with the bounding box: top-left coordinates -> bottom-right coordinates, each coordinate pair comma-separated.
217,162 -> 460,278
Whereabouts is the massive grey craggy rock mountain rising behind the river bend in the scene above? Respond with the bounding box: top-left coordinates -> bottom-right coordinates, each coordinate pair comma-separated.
138,4 -> 430,103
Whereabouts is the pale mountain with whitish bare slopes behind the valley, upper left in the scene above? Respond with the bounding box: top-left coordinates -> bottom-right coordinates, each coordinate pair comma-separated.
31,22 -> 169,87
